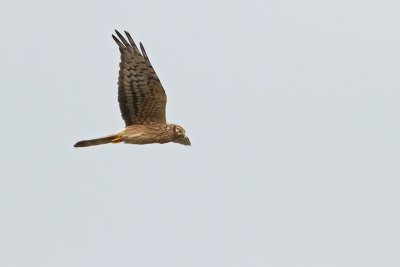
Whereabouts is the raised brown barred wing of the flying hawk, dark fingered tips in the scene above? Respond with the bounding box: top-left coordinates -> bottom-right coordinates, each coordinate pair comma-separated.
112,30 -> 167,126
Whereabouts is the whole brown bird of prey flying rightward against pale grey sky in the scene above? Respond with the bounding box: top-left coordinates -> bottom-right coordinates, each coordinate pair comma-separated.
74,30 -> 190,150
